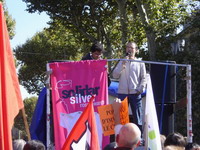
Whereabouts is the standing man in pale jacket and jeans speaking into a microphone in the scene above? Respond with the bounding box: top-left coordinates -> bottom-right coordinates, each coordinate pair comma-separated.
113,42 -> 146,131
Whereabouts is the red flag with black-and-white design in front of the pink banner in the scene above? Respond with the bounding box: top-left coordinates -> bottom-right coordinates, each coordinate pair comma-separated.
62,96 -> 100,150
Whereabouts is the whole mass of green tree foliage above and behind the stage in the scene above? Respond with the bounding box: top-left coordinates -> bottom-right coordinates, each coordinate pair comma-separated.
15,0 -> 194,93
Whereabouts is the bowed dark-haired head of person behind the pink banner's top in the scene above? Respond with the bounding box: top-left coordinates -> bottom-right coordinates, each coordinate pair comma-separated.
90,42 -> 103,60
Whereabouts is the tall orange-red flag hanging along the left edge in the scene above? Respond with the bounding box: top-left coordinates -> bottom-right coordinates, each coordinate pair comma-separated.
0,3 -> 24,150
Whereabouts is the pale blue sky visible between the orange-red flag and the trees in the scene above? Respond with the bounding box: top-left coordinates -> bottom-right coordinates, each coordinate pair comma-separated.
6,0 -> 49,99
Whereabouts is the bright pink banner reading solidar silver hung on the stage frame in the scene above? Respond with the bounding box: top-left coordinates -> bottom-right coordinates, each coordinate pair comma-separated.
49,60 -> 109,150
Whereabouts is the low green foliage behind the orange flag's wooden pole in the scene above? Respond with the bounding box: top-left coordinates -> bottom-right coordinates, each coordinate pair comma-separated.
14,97 -> 37,138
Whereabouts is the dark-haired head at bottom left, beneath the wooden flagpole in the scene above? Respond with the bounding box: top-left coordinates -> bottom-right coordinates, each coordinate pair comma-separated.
23,140 -> 45,150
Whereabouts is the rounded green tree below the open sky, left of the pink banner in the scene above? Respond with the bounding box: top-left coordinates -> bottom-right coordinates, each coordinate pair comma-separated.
14,24 -> 87,94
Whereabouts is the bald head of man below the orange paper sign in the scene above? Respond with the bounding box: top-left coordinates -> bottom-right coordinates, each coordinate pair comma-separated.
116,123 -> 141,148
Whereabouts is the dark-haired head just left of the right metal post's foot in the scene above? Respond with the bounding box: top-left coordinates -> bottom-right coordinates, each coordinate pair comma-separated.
164,133 -> 186,147
